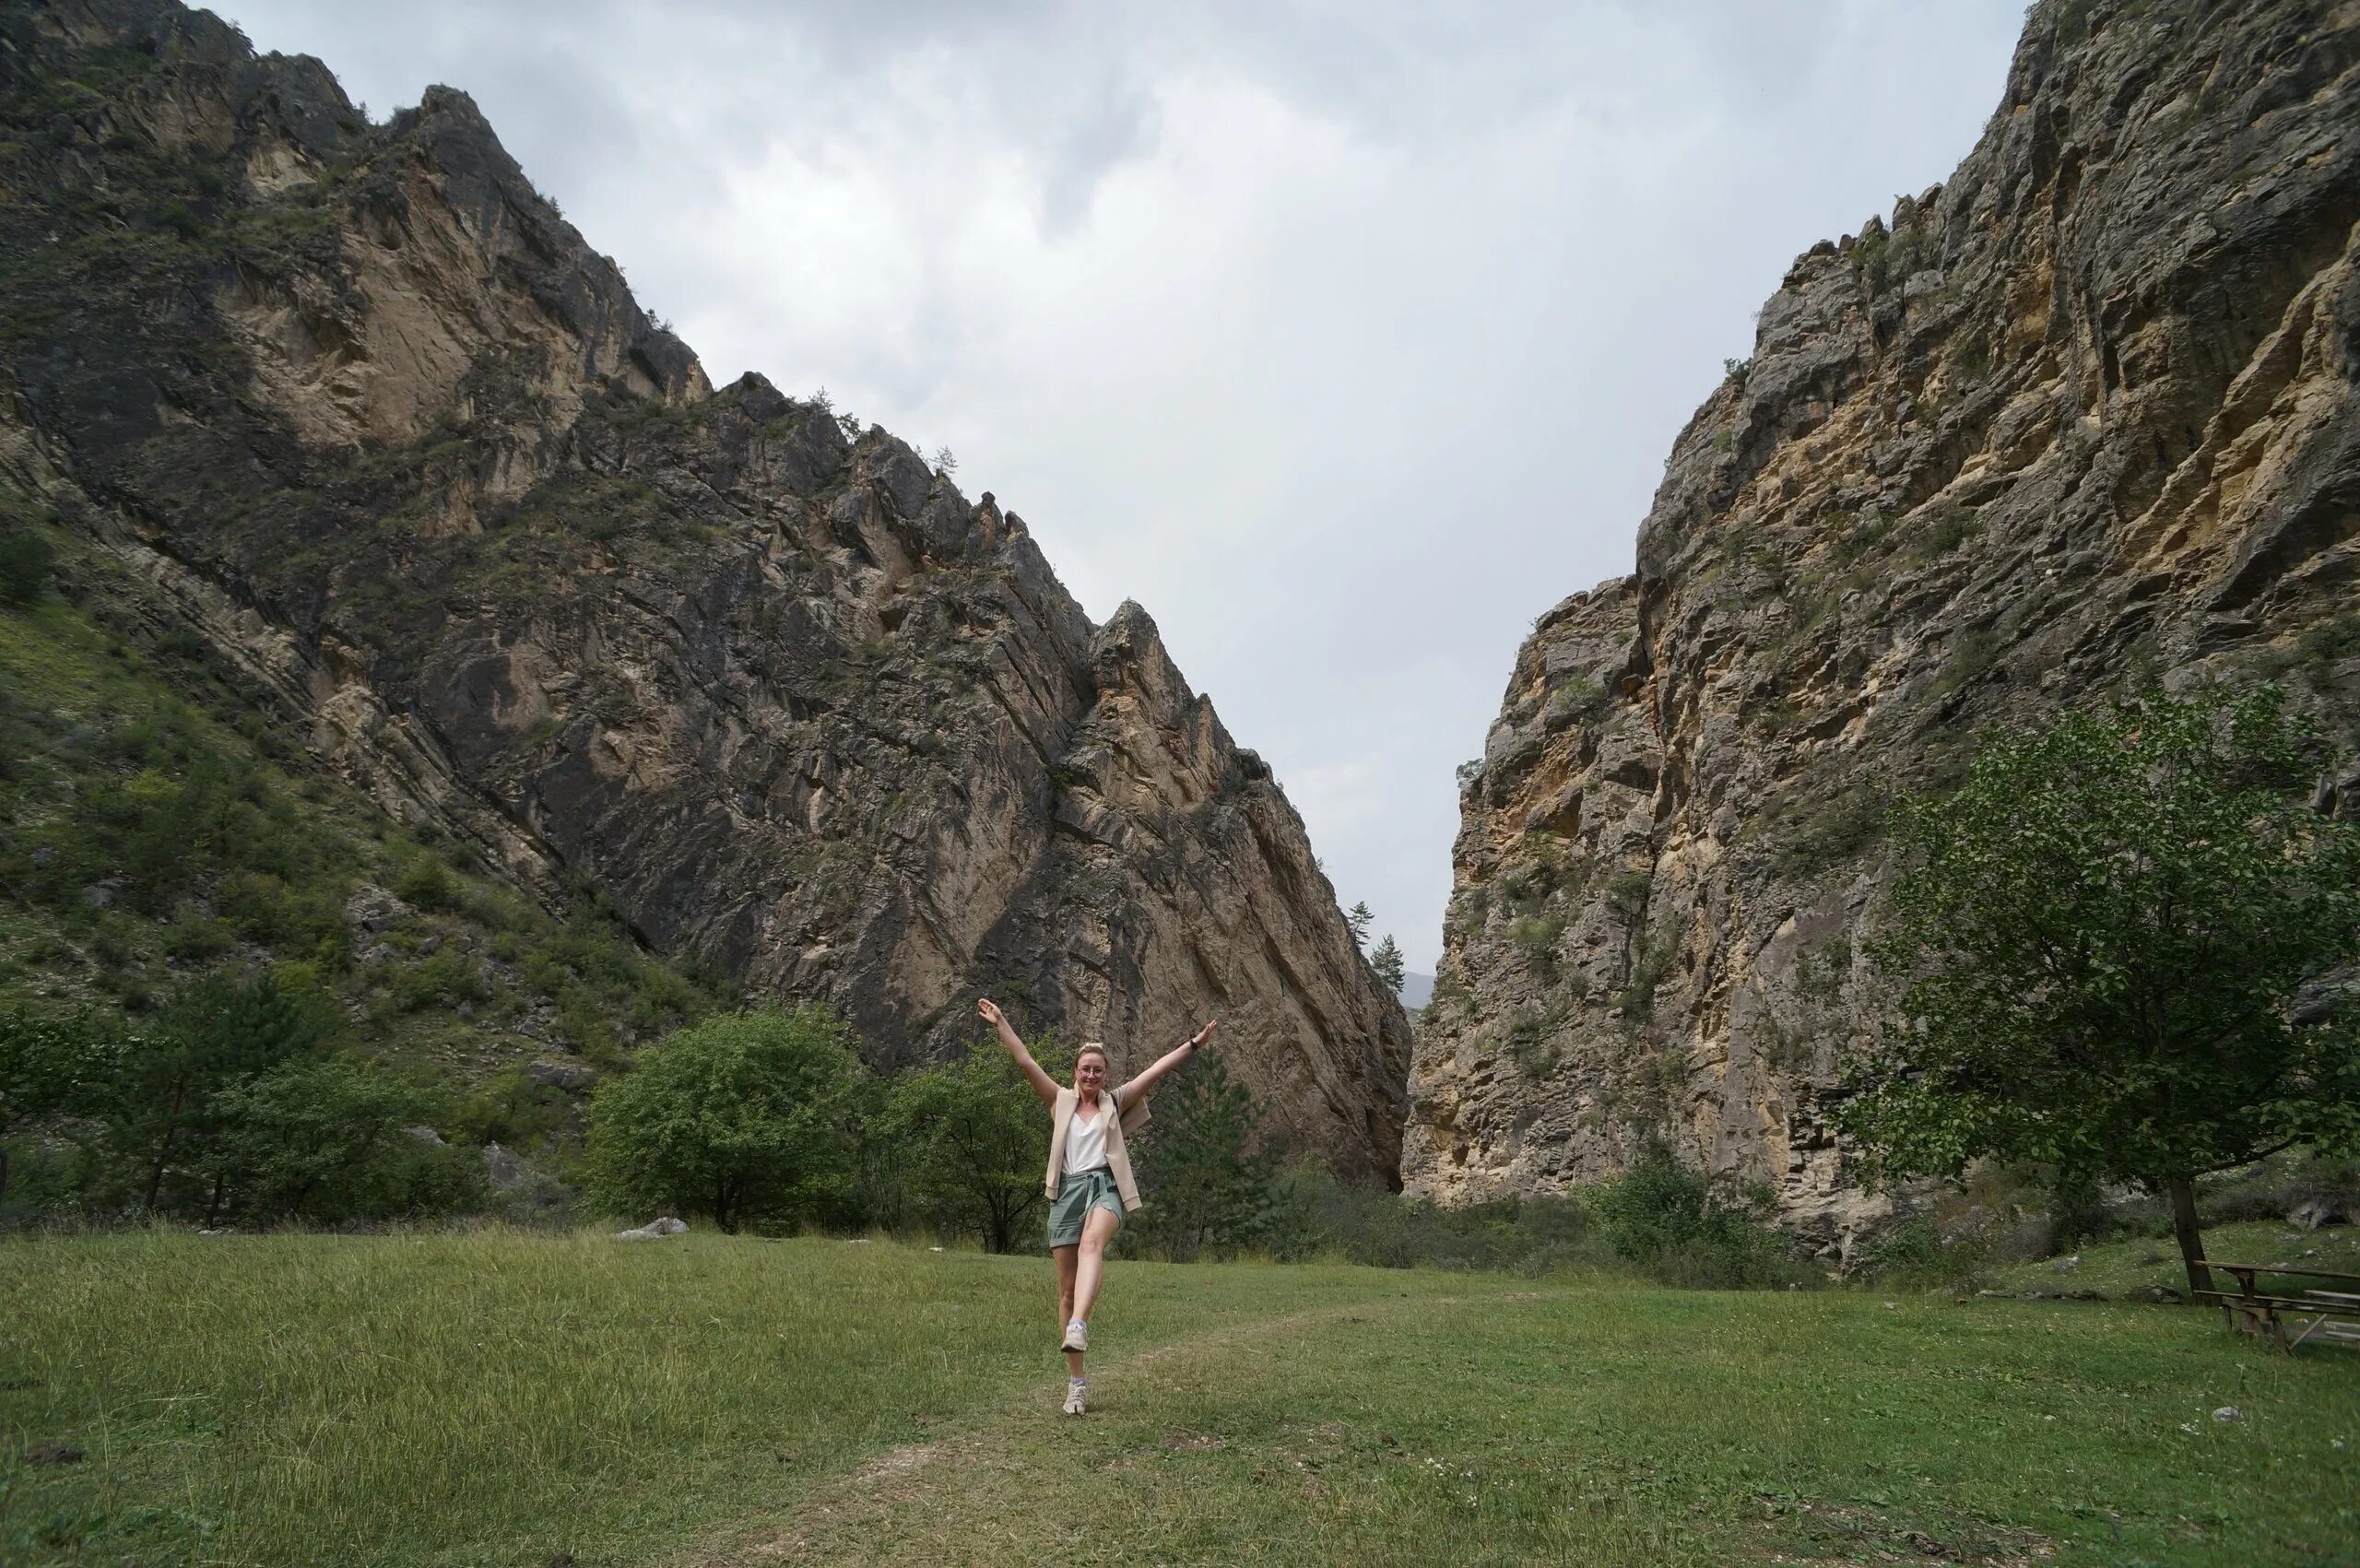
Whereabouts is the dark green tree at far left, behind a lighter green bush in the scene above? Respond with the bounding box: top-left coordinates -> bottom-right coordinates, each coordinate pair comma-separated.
109,973 -> 333,1211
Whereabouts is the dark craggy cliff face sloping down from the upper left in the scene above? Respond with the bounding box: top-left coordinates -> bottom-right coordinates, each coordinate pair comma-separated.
0,0 -> 1409,1178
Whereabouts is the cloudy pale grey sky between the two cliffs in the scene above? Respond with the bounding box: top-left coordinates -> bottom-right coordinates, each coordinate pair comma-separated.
218,0 -> 2023,971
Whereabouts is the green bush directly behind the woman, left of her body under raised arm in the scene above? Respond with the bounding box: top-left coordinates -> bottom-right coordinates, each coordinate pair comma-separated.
880,1043 -> 1048,1252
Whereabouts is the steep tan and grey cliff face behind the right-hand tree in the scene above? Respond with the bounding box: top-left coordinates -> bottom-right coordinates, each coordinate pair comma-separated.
1404,0 -> 2360,1244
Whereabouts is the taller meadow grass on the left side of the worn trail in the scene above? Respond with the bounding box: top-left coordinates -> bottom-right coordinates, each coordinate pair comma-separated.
0,1231 -> 1513,1568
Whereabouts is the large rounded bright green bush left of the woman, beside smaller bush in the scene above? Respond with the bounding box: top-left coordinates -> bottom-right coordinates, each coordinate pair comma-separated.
587,1006 -> 867,1232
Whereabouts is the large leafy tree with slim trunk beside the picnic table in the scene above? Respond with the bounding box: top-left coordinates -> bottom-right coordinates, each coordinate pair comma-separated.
1836,687 -> 2360,1290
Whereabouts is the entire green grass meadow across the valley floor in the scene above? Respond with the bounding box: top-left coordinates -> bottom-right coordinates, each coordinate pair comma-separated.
0,1231 -> 2360,1568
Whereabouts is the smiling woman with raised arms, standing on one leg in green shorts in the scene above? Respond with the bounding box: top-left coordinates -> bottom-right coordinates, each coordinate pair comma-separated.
974,996 -> 1218,1414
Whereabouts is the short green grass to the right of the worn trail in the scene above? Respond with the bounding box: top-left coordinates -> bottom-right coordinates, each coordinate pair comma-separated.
702,1285 -> 2360,1568
